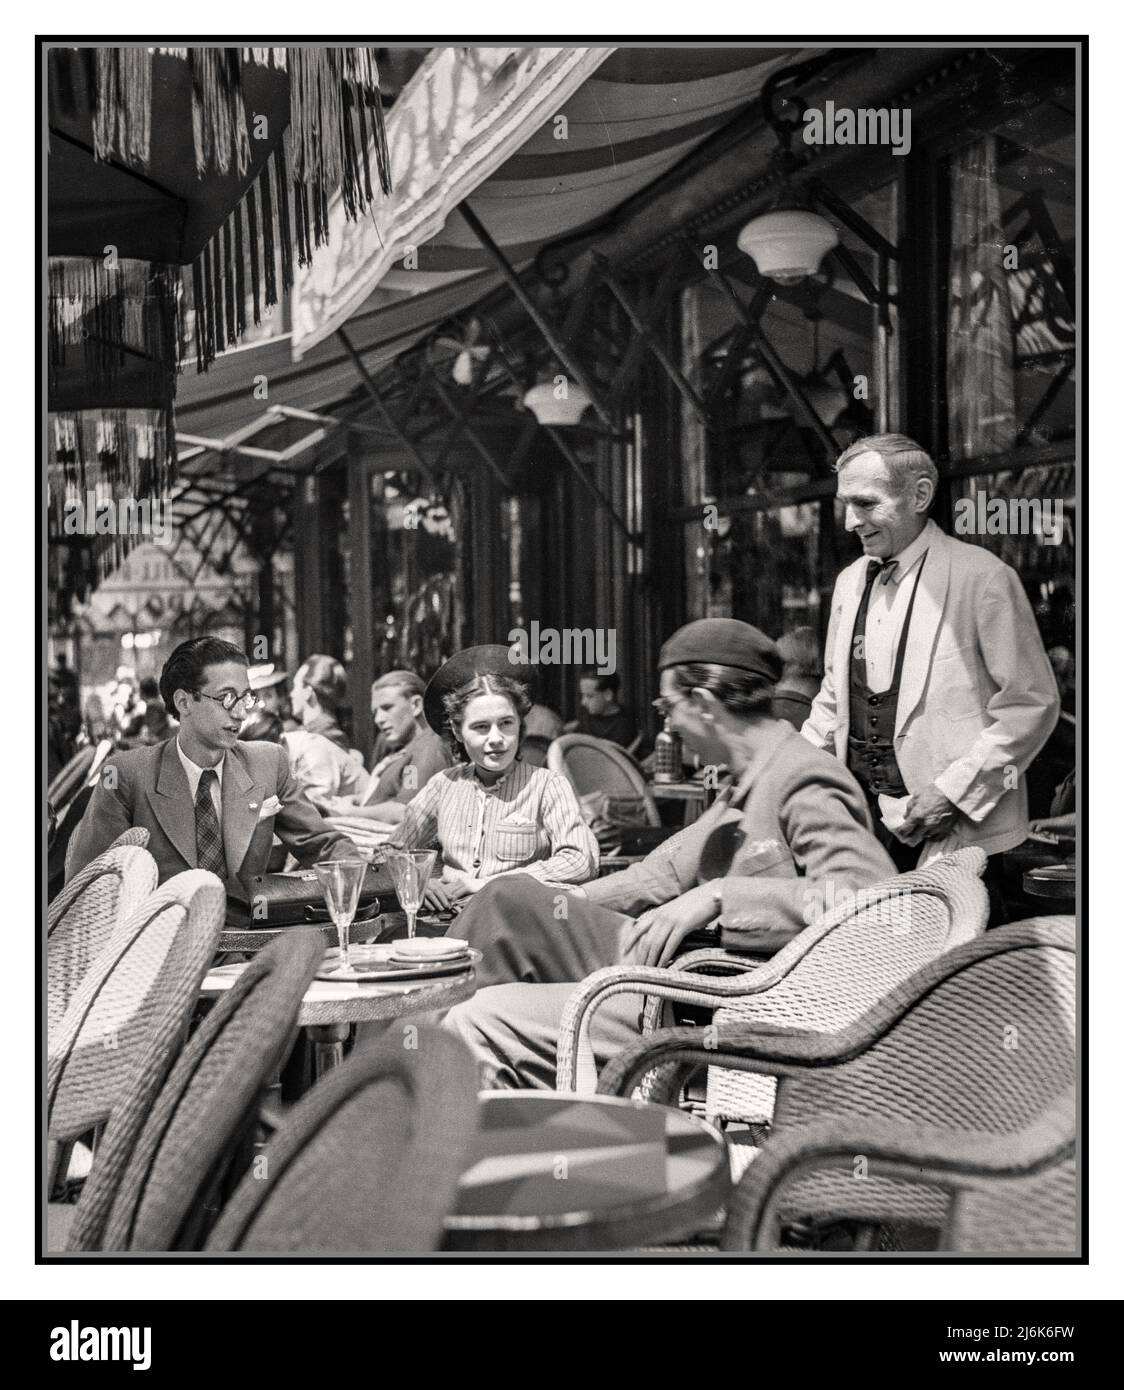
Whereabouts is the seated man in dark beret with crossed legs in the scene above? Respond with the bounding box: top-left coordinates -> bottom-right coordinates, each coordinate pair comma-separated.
445,619 -> 895,1087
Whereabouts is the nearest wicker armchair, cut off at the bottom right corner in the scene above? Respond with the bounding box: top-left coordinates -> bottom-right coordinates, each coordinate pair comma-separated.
722,1087 -> 1080,1257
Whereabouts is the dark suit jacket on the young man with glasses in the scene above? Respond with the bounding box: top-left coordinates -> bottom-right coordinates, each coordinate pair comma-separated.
67,738 -> 358,887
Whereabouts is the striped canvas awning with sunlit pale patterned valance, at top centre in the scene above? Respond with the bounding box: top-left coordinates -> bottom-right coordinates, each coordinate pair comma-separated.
292,47 -> 791,360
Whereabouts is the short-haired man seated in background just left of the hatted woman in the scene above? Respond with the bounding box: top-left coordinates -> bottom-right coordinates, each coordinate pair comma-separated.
329,671 -> 453,826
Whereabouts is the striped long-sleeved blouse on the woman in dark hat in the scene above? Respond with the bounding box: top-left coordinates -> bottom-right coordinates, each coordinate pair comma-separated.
388,760 -> 599,883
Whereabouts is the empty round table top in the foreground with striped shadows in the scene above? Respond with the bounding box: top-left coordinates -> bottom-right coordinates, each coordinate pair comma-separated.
445,1091 -> 729,1251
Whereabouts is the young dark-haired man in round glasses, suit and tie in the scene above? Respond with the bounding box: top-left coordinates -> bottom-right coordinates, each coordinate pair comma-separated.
67,637 -> 358,885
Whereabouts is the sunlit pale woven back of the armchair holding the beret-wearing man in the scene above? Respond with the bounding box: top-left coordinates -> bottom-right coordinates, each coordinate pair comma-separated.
707,847 -> 988,1123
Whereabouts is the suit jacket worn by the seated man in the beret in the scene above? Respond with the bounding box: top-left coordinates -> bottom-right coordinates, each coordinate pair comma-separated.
585,721 -> 896,951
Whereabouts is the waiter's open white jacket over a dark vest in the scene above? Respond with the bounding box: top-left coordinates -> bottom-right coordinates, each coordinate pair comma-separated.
800,521 -> 1060,863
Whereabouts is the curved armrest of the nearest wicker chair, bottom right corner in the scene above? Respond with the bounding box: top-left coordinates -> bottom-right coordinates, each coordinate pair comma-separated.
722,1093 -> 1074,1250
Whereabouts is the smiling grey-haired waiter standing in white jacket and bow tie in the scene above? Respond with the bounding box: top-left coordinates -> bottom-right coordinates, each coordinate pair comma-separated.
800,434 -> 1059,870
